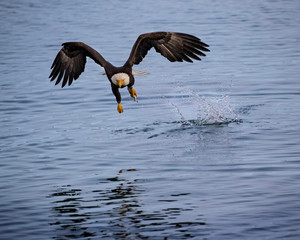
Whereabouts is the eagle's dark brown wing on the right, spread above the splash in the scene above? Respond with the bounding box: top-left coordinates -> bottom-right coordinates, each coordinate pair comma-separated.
126,32 -> 209,66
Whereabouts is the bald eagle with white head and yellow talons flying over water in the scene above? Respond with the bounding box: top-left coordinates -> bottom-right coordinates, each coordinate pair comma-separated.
49,32 -> 209,113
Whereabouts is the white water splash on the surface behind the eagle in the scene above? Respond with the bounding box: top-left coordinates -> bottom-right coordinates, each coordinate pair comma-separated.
170,89 -> 241,126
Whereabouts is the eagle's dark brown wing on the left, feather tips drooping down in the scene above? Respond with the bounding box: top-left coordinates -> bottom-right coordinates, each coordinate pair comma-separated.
49,42 -> 107,87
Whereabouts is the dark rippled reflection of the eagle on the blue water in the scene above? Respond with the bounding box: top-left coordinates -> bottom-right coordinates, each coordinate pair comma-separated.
48,169 -> 205,239
